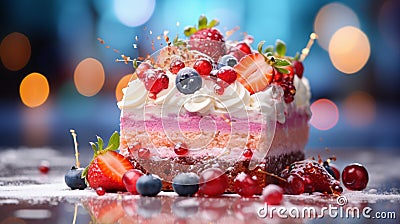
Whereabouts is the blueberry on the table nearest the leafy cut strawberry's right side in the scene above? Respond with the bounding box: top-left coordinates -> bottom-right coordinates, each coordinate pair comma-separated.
136,174 -> 162,196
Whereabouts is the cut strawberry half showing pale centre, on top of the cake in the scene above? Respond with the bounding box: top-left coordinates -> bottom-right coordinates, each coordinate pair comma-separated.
234,53 -> 273,94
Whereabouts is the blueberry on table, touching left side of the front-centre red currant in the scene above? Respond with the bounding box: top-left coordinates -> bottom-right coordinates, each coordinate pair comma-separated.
172,173 -> 200,196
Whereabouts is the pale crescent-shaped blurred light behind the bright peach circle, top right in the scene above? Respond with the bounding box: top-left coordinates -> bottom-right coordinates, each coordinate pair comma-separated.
314,2 -> 360,50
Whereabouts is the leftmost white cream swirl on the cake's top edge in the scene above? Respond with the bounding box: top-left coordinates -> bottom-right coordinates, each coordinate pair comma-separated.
117,79 -> 148,109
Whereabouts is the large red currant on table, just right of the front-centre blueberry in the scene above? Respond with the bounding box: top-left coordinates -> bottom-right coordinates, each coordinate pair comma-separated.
199,168 -> 228,197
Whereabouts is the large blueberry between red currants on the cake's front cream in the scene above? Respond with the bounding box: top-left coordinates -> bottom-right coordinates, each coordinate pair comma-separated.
175,67 -> 202,94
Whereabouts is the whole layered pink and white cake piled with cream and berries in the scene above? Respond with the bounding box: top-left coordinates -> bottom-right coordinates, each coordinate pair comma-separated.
118,16 -> 311,193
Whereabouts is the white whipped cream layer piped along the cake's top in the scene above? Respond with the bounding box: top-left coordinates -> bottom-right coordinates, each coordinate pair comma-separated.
118,71 -> 311,123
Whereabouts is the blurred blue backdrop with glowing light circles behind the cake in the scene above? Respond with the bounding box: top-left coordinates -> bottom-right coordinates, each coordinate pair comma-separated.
0,0 -> 400,150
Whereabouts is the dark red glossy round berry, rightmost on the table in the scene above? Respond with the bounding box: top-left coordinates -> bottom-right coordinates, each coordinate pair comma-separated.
342,163 -> 369,191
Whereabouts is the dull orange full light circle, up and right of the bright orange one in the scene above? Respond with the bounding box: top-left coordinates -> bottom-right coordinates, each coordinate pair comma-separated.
74,58 -> 105,97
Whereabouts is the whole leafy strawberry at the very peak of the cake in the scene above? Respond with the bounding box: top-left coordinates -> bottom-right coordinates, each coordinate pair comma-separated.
184,16 -> 226,61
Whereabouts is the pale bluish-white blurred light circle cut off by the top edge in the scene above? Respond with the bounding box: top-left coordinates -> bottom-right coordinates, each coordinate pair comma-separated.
114,0 -> 156,27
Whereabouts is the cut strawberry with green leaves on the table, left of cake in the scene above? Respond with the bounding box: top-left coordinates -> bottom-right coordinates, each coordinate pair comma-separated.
82,132 -> 133,191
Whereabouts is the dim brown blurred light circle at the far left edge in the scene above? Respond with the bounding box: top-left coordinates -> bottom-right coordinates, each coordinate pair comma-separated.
0,32 -> 31,71
